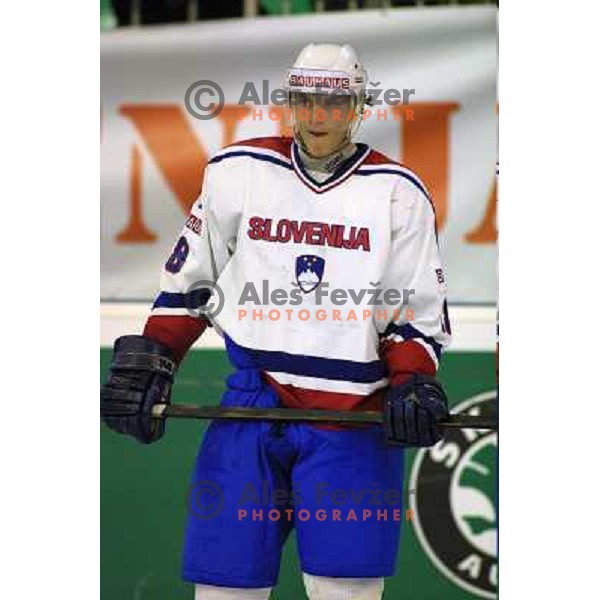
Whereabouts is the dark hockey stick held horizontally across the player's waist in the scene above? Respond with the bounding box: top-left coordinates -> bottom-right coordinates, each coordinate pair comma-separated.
152,404 -> 498,430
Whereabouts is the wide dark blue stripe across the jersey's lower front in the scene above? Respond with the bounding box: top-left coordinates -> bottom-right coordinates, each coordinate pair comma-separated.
225,336 -> 385,383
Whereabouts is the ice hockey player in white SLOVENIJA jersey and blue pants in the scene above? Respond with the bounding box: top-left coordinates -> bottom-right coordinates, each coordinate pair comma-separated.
101,44 -> 450,600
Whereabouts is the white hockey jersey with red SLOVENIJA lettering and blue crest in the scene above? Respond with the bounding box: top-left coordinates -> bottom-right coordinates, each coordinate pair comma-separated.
152,137 -> 450,409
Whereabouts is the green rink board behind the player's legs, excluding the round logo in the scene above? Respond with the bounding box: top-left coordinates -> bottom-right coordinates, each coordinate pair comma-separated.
100,349 -> 495,600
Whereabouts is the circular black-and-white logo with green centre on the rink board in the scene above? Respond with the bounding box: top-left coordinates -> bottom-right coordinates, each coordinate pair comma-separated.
410,390 -> 498,598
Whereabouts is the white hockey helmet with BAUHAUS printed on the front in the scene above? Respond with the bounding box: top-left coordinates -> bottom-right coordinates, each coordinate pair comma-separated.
284,44 -> 368,139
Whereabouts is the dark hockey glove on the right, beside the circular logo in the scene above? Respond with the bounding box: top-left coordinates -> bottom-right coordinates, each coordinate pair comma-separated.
384,375 -> 448,446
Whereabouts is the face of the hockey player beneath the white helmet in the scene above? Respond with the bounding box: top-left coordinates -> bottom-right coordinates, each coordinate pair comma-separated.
292,94 -> 353,158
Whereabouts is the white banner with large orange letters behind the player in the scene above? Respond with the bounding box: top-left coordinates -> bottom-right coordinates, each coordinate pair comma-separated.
101,7 -> 498,304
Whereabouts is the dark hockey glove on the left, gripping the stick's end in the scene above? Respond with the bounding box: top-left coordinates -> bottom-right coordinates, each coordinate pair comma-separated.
100,335 -> 177,444
